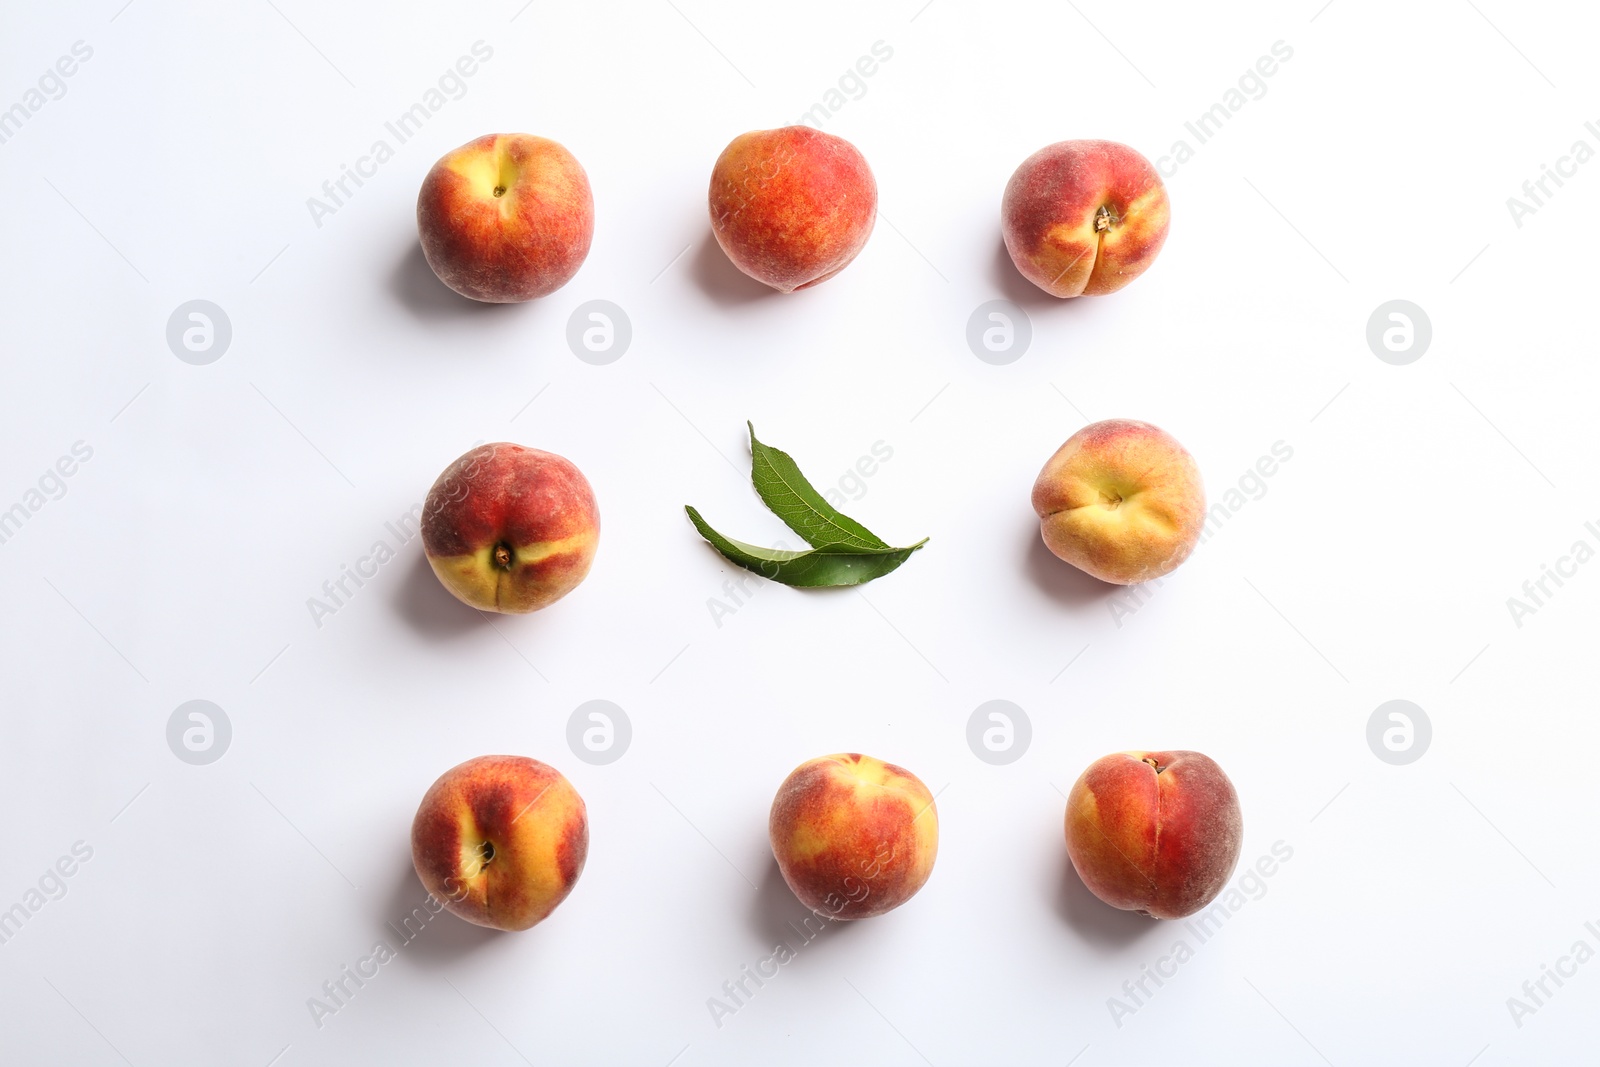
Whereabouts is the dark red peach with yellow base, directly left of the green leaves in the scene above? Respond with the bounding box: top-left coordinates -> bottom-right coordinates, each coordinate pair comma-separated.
422,442 -> 600,614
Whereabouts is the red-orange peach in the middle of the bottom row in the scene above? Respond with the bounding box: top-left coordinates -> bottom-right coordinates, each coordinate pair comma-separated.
768,752 -> 939,920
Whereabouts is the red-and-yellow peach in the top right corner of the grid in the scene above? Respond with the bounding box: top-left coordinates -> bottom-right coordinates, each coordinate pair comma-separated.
1000,141 -> 1171,296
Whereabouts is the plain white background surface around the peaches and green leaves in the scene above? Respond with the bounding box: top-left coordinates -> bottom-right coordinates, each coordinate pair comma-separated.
0,0 -> 1600,1067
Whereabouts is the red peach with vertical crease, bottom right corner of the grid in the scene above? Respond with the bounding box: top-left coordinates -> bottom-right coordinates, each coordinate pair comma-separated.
1067,752 -> 1245,918
